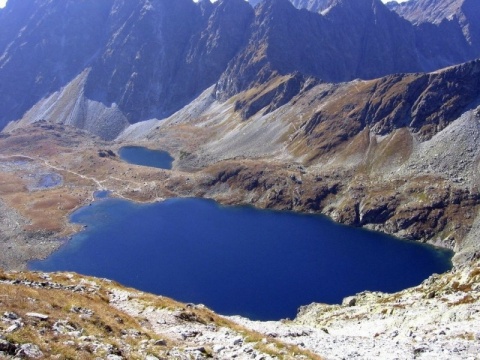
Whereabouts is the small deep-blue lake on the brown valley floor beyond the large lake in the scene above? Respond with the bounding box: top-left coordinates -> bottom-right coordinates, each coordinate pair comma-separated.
118,146 -> 174,170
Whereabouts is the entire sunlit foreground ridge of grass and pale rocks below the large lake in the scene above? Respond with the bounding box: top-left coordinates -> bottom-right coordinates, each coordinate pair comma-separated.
0,262 -> 480,360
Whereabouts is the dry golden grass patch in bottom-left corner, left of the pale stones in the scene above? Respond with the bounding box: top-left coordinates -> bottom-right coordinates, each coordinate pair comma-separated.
0,273 -> 172,359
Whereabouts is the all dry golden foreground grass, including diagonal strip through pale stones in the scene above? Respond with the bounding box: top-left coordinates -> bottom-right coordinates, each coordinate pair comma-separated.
0,270 -> 322,360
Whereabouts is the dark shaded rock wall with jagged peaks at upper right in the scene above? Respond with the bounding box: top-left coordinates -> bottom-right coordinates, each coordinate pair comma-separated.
217,0 -> 480,100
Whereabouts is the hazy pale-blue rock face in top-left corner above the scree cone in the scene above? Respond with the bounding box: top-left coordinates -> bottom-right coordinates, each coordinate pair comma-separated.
0,0 -> 113,128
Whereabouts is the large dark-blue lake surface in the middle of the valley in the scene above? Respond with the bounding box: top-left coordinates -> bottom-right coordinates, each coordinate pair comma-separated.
30,198 -> 452,320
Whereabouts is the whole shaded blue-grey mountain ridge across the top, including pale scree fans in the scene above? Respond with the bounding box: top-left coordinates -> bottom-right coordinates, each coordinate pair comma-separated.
0,0 -> 480,139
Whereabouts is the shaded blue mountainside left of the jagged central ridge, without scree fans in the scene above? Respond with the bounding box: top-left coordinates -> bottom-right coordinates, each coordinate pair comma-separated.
0,0 -> 253,133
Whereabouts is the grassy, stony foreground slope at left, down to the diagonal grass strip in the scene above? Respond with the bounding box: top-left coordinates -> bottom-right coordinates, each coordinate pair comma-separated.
0,273 -> 320,360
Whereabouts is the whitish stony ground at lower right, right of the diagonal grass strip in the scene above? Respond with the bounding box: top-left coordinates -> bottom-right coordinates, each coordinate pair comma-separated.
236,262 -> 480,360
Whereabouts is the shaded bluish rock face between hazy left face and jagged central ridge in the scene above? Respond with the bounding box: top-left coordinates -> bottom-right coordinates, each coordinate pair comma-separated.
86,0 -> 253,123
